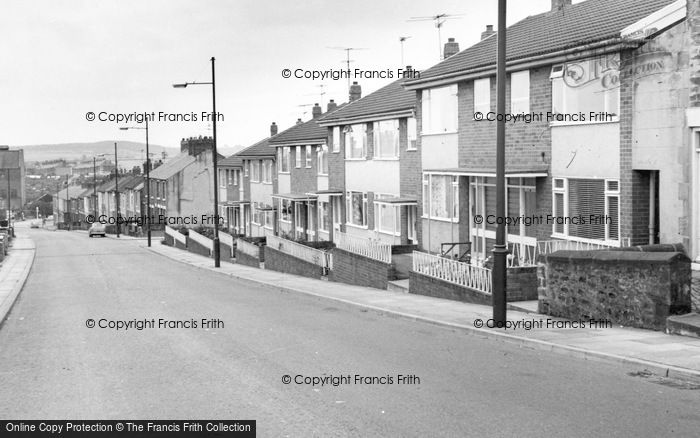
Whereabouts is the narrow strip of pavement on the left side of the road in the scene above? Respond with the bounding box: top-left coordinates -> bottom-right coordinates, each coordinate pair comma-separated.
0,234 -> 36,325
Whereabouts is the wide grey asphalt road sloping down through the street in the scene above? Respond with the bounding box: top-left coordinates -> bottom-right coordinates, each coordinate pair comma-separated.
0,230 -> 700,437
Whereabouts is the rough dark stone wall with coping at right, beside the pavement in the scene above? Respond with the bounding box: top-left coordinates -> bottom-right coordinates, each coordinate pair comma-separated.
538,251 -> 691,330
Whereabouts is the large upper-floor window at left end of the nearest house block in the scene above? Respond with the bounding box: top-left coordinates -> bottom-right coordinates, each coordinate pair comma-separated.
422,85 -> 457,134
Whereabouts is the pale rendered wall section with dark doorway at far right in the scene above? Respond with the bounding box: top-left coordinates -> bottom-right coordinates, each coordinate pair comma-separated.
619,21 -> 700,250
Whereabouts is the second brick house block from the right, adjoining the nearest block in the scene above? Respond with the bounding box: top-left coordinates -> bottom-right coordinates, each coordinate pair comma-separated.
319,79 -> 420,245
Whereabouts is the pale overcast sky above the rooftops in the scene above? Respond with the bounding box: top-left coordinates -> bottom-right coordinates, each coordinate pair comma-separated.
0,0 -> 564,154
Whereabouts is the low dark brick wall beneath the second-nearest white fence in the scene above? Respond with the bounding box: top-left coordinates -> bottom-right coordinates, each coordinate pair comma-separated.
328,248 -> 396,289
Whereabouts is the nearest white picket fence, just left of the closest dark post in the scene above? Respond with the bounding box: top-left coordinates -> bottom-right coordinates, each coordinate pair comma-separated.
413,251 -> 492,294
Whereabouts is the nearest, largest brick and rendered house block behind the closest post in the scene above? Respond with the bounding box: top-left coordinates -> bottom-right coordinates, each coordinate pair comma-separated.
406,0 -> 687,264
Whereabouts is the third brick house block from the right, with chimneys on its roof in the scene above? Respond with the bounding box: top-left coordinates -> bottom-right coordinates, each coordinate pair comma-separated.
269,100 -> 339,241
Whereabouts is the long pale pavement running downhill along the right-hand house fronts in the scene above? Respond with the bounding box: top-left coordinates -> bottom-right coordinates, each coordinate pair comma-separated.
142,240 -> 700,380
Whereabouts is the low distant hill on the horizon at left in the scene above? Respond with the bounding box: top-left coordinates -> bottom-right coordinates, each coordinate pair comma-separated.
16,140 -> 180,163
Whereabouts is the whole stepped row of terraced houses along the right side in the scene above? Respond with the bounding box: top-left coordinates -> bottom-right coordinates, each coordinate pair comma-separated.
170,0 -> 700,301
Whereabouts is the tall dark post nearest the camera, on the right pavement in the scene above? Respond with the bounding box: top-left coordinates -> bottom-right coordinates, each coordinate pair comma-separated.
491,0 -> 508,327
